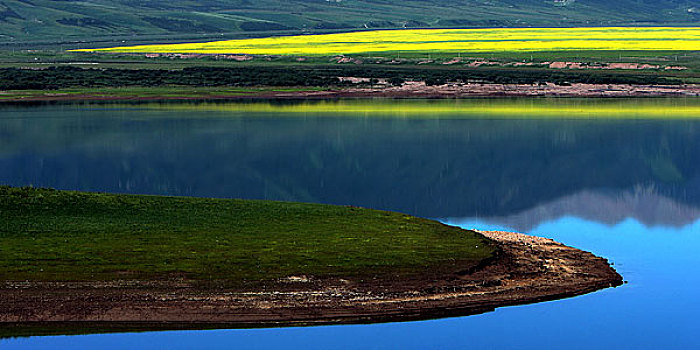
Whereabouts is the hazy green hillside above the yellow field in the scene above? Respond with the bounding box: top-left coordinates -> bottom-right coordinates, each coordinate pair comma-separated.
0,0 -> 700,44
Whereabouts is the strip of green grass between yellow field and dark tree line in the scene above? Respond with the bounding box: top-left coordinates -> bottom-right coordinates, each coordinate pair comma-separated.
0,49 -> 700,70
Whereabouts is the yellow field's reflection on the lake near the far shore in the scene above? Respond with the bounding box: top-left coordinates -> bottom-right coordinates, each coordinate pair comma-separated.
129,97 -> 700,119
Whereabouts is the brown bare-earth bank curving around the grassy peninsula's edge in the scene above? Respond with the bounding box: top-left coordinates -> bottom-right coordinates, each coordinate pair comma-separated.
0,231 -> 623,337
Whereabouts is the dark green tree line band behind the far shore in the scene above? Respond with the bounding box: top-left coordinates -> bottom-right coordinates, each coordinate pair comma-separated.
0,65 -> 683,90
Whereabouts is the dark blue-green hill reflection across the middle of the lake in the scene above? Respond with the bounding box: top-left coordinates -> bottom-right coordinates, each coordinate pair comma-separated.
0,102 -> 700,217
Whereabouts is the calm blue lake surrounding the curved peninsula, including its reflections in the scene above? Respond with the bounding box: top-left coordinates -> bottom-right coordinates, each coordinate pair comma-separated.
0,98 -> 700,350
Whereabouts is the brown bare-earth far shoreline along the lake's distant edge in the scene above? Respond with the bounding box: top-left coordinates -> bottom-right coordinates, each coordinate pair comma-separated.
0,82 -> 700,105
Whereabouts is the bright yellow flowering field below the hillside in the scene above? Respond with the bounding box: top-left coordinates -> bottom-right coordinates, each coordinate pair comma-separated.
76,28 -> 700,55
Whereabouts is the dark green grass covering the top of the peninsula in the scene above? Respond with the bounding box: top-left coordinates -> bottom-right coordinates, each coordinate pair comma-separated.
0,187 -> 495,287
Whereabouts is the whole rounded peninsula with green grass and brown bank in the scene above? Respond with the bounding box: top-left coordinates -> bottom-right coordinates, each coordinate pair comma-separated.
0,187 -> 622,338
